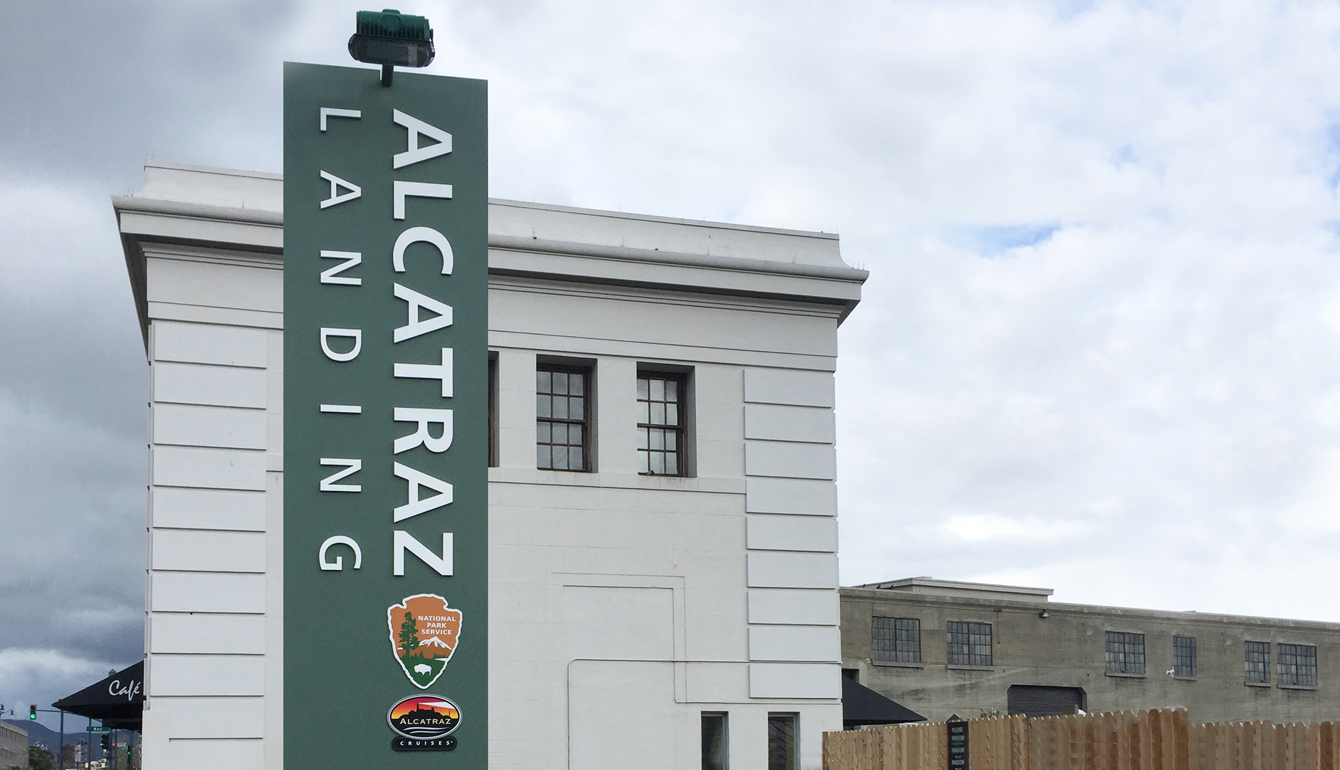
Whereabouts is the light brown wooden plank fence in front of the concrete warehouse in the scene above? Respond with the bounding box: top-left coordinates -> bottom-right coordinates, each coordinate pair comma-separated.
824,708 -> 1340,770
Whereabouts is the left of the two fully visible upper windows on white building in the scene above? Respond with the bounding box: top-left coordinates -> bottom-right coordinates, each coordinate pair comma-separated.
535,364 -> 591,470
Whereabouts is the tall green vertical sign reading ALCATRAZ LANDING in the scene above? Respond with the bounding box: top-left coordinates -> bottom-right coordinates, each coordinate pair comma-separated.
284,63 -> 488,770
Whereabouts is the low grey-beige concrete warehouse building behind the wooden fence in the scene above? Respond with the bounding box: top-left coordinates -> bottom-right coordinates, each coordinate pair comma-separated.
842,577 -> 1340,723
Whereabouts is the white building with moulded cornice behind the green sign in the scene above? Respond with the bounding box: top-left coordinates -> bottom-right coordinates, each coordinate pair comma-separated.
114,163 -> 866,770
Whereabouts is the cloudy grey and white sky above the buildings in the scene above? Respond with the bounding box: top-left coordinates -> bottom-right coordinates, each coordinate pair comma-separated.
0,0 -> 1340,716
